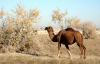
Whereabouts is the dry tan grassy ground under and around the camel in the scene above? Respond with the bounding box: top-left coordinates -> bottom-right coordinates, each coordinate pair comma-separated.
0,35 -> 100,64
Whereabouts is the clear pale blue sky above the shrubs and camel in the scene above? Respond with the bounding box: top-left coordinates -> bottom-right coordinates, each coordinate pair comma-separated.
0,0 -> 100,28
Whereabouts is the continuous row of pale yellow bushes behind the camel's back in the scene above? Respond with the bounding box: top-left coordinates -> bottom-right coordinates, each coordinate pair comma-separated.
52,8 -> 96,38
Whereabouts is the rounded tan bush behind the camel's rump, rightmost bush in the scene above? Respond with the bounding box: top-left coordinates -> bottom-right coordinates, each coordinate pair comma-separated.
83,21 -> 97,39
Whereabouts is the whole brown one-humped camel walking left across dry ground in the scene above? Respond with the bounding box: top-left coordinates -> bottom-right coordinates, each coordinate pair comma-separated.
45,26 -> 86,59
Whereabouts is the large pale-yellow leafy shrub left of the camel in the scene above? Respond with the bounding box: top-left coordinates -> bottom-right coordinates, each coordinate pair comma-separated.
0,4 -> 41,53
